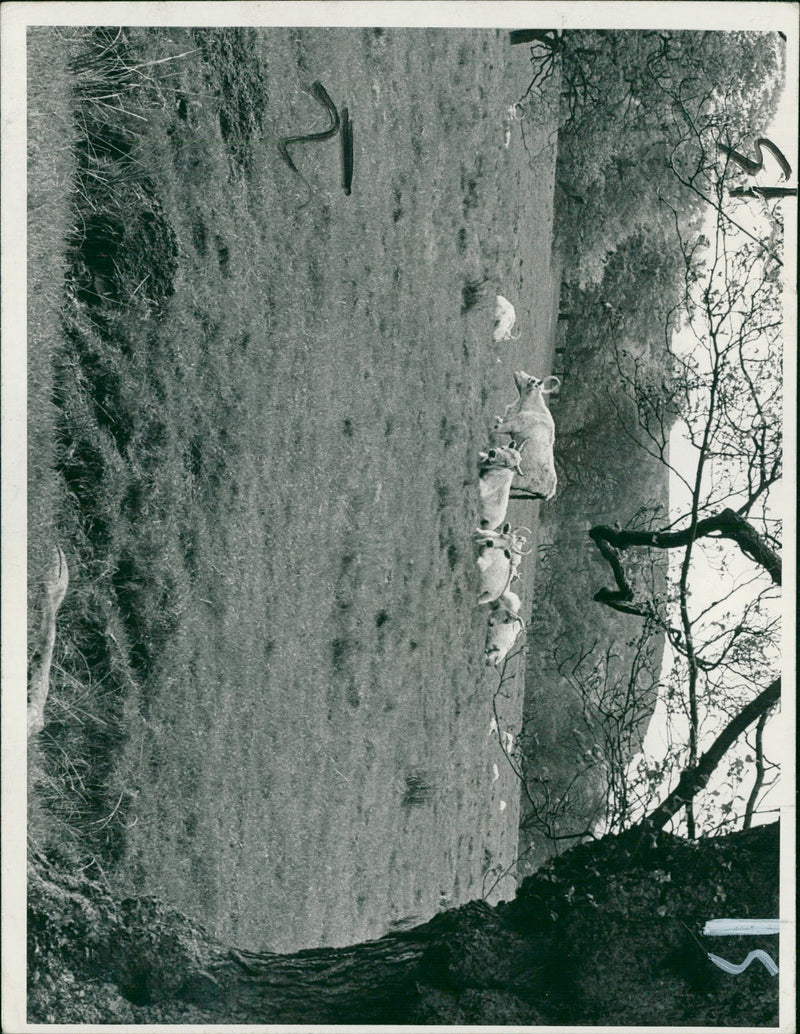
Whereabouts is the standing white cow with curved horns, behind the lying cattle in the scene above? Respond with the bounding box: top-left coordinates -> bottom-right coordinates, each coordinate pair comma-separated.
492,370 -> 561,499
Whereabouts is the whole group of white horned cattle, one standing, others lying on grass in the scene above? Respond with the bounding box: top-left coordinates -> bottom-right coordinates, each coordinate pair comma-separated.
472,295 -> 560,668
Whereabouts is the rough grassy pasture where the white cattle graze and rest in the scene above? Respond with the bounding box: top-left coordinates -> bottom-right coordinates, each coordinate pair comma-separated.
29,29 -> 558,950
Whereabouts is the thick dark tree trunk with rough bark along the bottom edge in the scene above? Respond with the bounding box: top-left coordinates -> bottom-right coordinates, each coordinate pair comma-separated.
28,824 -> 778,1026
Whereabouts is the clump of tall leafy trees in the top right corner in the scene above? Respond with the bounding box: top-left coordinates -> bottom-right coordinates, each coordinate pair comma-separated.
557,30 -> 784,284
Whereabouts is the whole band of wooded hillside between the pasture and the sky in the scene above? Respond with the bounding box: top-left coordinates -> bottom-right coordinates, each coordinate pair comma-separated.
520,31 -> 783,863
